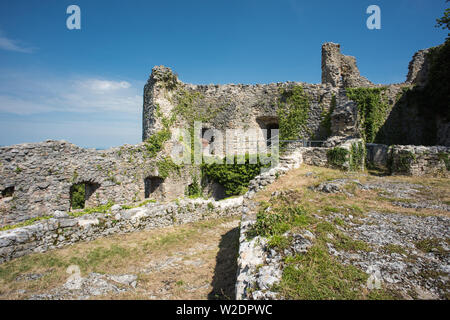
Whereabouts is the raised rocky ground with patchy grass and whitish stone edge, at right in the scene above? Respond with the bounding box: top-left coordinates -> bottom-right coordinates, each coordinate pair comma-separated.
238,167 -> 450,299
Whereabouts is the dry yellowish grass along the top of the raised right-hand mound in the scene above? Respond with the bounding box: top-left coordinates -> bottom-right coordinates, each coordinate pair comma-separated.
255,165 -> 450,216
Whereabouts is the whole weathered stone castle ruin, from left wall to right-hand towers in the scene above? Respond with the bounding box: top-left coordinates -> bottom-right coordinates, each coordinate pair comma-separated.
0,43 -> 450,226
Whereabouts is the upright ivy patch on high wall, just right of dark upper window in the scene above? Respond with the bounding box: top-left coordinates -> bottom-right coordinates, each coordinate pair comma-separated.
278,85 -> 310,144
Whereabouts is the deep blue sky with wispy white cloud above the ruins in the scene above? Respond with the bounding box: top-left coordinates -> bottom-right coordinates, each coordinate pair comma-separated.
0,0 -> 448,148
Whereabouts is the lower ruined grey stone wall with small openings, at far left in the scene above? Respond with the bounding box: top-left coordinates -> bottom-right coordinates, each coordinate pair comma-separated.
0,140 -> 192,225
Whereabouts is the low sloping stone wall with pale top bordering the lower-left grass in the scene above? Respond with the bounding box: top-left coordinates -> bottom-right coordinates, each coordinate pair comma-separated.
0,197 -> 243,263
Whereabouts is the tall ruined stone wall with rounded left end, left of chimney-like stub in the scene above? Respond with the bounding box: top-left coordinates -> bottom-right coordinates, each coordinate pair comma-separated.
143,66 -> 337,153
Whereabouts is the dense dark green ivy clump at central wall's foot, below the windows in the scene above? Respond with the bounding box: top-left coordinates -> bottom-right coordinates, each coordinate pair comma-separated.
202,154 -> 270,196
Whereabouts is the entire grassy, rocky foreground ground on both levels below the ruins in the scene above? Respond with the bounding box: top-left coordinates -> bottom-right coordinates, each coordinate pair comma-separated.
0,164 -> 450,300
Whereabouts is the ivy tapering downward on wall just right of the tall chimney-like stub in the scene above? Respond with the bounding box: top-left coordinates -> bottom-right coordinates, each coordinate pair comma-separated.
346,87 -> 389,143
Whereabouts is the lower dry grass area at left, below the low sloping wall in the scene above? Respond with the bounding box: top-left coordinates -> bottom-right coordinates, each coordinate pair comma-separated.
0,217 -> 239,299
